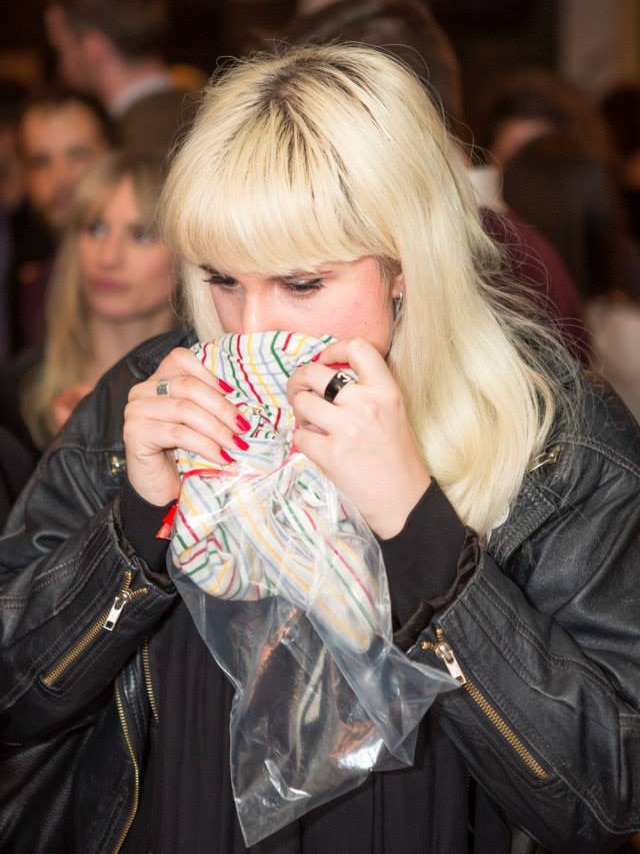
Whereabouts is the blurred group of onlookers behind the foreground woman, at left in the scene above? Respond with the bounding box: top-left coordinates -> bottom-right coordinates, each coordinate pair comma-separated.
0,0 -> 199,518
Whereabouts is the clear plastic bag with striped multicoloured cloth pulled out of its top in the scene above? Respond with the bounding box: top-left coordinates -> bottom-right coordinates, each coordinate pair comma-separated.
169,332 -> 455,845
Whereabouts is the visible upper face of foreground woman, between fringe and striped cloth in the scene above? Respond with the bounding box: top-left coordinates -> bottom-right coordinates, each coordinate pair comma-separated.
202,255 -> 403,355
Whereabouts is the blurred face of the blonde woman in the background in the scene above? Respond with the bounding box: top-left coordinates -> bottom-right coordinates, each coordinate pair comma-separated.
78,176 -> 176,323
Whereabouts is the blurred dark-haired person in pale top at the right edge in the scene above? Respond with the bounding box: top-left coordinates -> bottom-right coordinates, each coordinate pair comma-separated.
504,131 -> 640,420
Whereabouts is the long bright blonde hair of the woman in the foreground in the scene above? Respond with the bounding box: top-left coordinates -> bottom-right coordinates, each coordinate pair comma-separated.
161,45 -> 572,534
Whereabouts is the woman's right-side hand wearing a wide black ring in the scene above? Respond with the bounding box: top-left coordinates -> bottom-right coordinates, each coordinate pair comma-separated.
287,338 -> 431,539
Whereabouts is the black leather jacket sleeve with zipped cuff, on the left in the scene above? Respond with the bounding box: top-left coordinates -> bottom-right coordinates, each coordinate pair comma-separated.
0,358 -> 176,743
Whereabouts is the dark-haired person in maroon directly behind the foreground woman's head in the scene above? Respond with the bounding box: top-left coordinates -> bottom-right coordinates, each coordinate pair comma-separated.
281,0 -> 589,363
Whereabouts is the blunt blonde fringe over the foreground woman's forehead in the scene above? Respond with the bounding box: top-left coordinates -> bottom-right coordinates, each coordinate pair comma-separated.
164,115 -> 388,275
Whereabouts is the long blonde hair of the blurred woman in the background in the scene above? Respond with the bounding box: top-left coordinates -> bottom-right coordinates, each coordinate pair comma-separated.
21,152 -> 178,447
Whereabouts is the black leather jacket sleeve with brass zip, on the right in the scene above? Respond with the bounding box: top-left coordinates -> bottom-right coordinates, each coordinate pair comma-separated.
413,421 -> 640,854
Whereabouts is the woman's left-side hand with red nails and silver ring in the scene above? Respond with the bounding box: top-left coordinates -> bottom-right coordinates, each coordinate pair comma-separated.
124,347 -> 249,506
